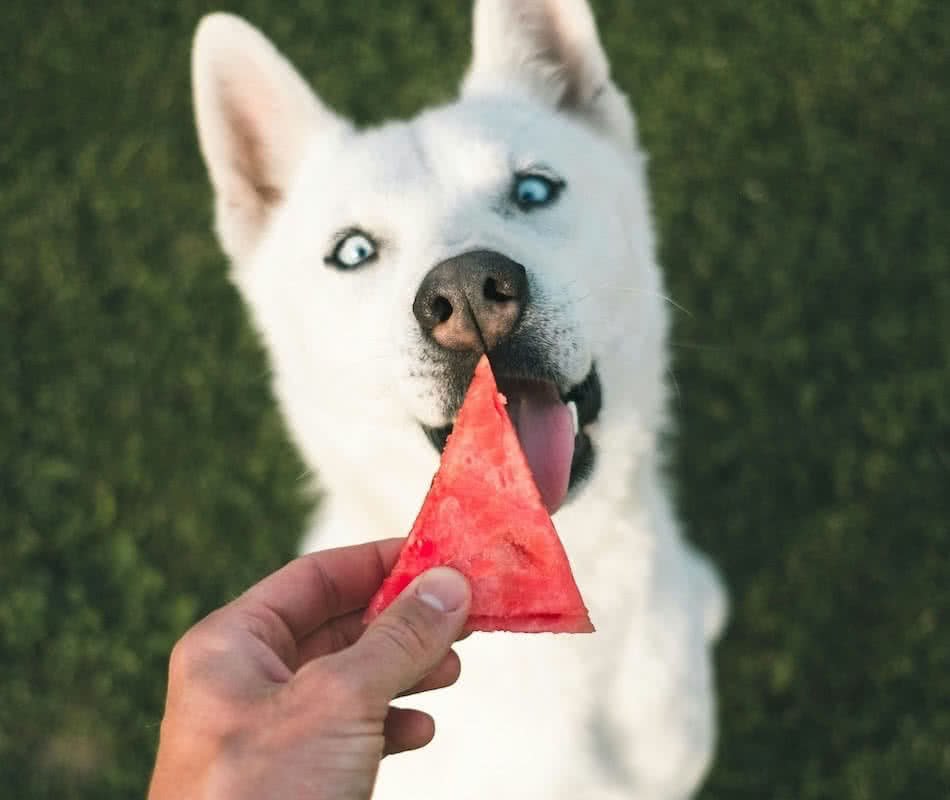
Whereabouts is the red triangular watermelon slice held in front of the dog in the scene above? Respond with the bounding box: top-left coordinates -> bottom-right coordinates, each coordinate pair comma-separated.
366,356 -> 594,633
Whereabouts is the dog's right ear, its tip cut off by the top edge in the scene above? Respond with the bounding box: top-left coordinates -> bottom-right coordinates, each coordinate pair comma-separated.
462,0 -> 633,145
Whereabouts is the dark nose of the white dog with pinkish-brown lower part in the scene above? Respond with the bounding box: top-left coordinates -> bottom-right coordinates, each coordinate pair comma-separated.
412,250 -> 528,351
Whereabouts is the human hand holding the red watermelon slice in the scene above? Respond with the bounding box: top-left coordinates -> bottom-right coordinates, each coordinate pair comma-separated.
149,539 -> 471,800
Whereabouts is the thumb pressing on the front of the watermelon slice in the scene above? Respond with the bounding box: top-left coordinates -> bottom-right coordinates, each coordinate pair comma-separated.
330,567 -> 471,705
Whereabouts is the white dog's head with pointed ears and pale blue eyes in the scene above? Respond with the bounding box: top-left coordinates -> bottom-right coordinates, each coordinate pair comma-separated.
193,0 -> 665,510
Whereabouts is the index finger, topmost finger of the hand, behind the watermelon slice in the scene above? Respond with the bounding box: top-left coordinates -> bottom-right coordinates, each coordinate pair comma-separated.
234,539 -> 405,642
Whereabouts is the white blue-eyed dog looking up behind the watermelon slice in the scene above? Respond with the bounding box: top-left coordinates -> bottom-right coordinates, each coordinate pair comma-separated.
193,0 -> 726,800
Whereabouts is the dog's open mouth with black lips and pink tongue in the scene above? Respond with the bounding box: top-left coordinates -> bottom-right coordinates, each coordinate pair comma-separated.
422,366 -> 601,514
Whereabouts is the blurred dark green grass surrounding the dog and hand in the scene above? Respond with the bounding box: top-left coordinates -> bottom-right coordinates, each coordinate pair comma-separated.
0,0 -> 950,800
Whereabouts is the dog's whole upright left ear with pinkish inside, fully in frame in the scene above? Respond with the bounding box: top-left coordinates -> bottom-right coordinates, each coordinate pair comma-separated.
191,13 -> 346,265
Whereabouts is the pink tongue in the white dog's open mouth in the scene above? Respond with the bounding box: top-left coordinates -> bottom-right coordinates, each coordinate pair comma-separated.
499,381 -> 574,514
